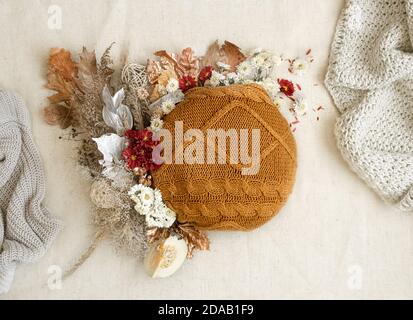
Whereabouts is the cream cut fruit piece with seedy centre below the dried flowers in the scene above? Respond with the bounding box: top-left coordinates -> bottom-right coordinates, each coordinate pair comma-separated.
144,236 -> 188,278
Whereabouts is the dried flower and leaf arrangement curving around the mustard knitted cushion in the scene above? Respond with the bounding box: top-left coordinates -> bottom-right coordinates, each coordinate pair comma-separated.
44,41 -> 319,277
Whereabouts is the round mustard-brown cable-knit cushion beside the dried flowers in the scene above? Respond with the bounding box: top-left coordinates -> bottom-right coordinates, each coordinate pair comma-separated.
154,85 -> 296,230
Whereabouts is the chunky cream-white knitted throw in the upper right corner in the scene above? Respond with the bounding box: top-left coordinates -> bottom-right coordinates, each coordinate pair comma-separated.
326,0 -> 413,210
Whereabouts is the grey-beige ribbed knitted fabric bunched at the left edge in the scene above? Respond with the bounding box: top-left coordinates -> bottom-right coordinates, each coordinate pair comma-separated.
0,90 -> 60,293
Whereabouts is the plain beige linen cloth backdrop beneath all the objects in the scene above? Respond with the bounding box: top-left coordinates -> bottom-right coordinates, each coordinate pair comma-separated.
0,0 -> 413,299
